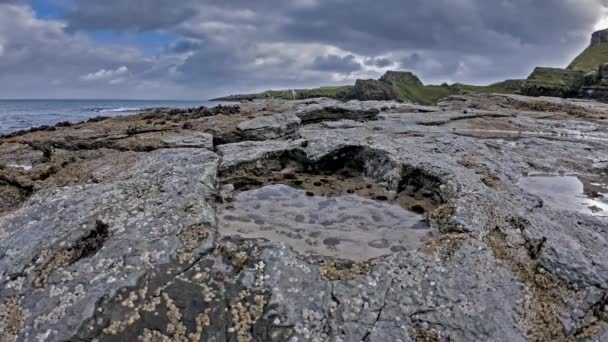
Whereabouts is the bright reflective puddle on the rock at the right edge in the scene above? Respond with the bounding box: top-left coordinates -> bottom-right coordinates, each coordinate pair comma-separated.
519,175 -> 608,217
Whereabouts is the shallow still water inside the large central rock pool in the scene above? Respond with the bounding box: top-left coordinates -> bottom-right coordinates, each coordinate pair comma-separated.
219,184 -> 430,261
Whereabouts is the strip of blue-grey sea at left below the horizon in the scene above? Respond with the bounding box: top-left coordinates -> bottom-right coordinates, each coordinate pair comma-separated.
0,100 -> 228,134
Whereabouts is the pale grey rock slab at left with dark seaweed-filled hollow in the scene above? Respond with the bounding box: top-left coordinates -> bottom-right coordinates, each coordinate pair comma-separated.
0,149 -> 219,340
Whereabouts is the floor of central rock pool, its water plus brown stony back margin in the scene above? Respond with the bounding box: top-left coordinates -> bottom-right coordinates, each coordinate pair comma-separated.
218,167 -> 441,262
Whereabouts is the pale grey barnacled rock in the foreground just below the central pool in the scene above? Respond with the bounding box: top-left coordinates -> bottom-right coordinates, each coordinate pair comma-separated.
261,238 -> 526,341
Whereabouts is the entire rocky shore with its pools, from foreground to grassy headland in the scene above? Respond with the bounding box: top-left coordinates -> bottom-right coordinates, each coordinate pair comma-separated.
0,95 -> 608,341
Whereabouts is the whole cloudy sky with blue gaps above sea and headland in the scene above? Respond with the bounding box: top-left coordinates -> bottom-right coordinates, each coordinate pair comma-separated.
0,0 -> 608,100
